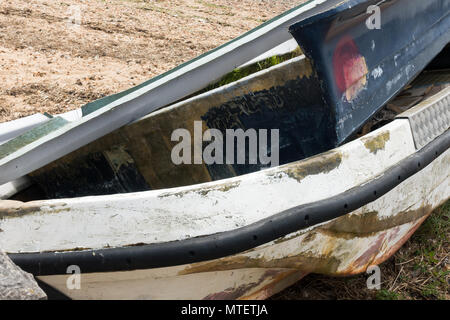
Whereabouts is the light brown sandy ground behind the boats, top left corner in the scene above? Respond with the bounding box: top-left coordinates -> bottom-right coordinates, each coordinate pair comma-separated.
0,0 -> 305,122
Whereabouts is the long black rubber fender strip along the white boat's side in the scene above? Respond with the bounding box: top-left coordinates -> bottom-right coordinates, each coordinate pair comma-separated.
9,130 -> 450,275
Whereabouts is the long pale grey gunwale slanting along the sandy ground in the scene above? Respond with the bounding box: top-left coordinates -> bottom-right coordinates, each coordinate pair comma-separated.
0,0 -> 339,184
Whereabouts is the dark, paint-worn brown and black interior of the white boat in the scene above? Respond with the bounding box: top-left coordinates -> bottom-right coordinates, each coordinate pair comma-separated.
6,46 -> 450,201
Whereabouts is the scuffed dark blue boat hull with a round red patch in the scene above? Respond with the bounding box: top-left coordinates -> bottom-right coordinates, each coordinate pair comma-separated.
289,0 -> 450,145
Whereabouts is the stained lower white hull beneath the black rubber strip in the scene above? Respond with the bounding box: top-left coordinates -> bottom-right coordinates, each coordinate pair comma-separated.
39,151 -> 450,300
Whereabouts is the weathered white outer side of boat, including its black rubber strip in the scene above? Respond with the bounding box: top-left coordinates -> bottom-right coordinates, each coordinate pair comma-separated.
0,88 -> 450,299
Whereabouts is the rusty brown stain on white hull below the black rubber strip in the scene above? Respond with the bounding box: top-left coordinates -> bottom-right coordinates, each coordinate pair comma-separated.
179,205 -> 440,275
